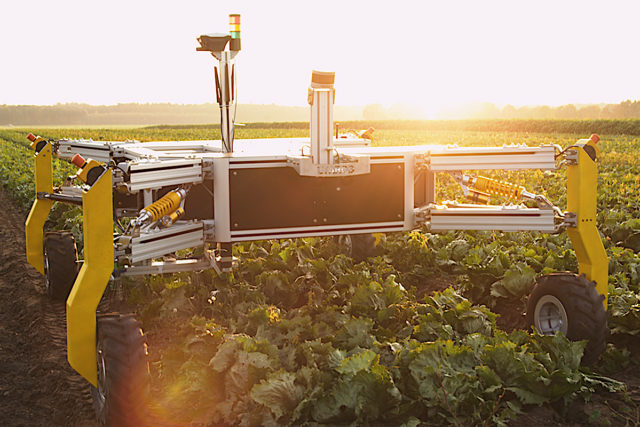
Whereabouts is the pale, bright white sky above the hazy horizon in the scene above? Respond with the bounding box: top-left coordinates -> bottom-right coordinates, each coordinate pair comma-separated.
0,0 -> 640,114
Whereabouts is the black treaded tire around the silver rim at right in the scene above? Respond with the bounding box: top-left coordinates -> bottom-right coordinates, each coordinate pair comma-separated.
526,273 -> 609,365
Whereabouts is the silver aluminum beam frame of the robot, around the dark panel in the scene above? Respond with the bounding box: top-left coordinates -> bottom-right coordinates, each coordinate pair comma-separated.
51,138 -> 559,274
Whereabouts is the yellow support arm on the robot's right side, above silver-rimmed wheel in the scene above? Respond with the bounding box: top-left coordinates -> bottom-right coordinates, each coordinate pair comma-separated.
567,142 -> 609,309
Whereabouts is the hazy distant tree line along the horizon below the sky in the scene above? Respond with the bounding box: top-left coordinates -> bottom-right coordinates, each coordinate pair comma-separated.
0,100 -> 640,126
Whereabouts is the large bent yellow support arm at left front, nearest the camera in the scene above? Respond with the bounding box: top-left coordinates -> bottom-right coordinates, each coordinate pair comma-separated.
67,169 -> 114,386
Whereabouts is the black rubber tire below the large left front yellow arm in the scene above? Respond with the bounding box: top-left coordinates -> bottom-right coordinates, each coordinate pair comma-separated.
91,313 -> 151,426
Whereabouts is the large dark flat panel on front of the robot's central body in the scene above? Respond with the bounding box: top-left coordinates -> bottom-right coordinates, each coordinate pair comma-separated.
229,163 -> 404,231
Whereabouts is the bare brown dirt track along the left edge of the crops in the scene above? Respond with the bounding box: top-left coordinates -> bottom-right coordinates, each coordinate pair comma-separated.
0,191 -> 96,426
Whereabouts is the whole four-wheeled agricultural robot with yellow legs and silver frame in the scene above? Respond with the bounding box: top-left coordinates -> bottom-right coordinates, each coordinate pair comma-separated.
26,15 -> 608,425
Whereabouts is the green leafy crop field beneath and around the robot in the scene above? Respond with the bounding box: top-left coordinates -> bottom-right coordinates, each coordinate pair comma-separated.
0,121 -> 640,426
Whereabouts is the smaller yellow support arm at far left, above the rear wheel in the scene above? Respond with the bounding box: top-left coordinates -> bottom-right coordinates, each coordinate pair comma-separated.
24,143 -> 53,274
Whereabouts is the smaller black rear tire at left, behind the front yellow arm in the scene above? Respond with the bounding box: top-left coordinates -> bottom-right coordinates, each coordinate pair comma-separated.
44,231 -> 78,301
